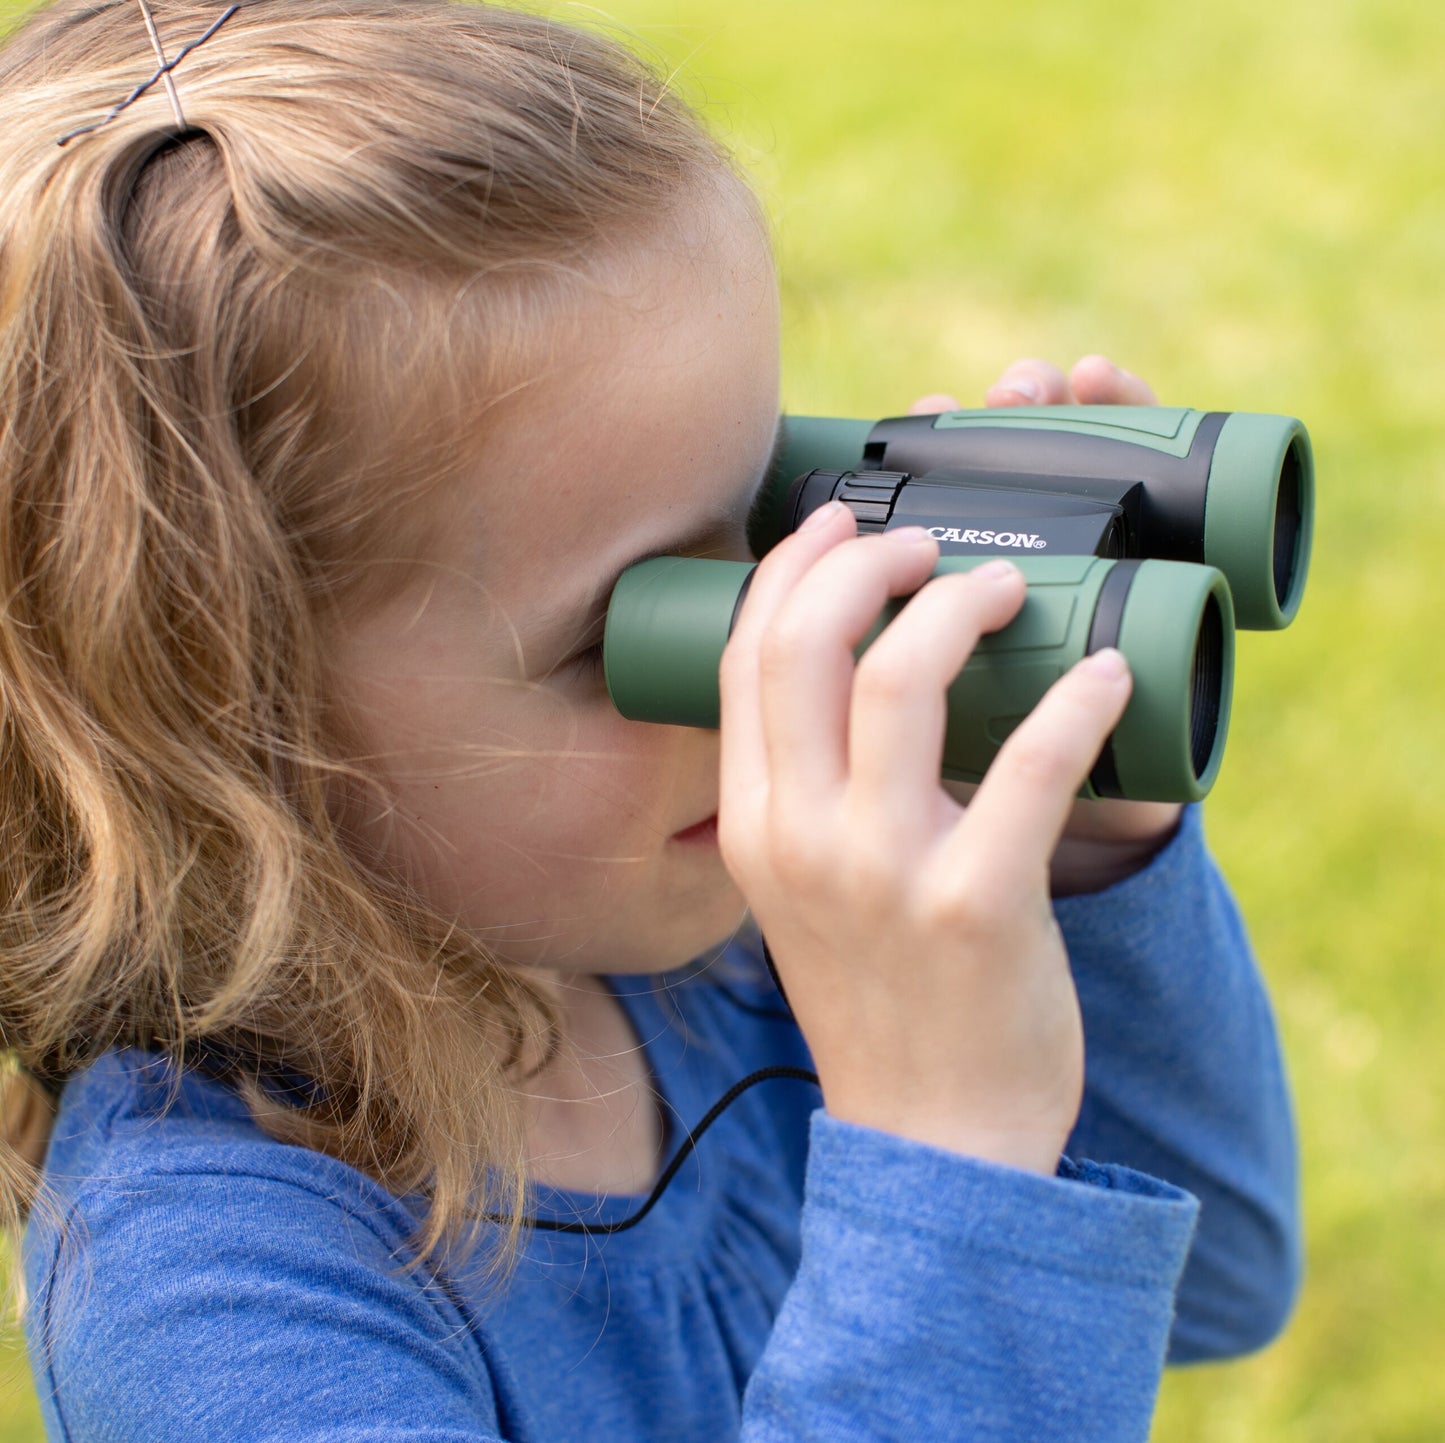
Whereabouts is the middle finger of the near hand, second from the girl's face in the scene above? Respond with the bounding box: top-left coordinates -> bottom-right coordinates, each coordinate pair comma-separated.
759,527 -> 938,807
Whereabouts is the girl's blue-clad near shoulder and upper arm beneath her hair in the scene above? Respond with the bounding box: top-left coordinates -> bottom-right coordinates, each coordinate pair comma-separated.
25,1053 -> 508,1439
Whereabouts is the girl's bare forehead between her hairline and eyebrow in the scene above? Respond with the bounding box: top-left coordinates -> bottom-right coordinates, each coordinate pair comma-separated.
444,196 -> 777,644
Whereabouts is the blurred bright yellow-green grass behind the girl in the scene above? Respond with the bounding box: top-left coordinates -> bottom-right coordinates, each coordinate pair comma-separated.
0,0 -> 1445,1443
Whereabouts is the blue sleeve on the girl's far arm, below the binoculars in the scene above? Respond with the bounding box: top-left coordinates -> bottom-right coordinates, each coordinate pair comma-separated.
1055,807 -> 1301,1362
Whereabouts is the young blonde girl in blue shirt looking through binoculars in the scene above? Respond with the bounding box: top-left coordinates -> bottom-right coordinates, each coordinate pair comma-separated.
0,0 -> 1295,1443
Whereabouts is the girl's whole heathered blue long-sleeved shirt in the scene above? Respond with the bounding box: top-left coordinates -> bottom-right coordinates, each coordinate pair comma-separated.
26,813 -> 1298,1443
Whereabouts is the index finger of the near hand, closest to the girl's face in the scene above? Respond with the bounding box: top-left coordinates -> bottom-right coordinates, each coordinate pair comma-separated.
718,501 -> 857,826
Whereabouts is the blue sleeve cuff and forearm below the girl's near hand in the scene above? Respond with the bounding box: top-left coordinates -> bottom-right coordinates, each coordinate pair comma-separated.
743,1112 -> 1195,1443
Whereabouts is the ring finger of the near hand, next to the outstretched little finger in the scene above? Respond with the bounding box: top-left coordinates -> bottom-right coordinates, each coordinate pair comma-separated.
848,560 -> 1027,845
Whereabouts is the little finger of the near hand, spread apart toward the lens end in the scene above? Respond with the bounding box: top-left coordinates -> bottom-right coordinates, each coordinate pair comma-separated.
945,649 -> 1131,897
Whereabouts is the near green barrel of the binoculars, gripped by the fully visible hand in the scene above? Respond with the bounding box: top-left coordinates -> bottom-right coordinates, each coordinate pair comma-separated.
604,556 -> 1234,802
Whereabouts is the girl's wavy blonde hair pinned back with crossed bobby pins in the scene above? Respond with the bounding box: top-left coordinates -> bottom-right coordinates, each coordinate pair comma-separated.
0,0 -> 727,1255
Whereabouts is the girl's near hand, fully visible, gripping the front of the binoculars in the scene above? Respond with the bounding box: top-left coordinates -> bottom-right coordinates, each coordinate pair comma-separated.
718,504 -> 1130,1173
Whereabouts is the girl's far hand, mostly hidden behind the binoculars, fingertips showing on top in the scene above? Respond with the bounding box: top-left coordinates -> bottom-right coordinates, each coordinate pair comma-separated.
909,355 -> 1182,897
